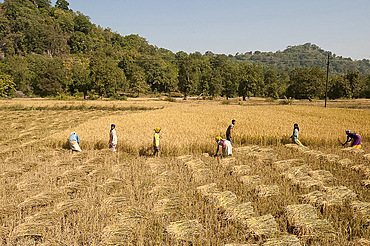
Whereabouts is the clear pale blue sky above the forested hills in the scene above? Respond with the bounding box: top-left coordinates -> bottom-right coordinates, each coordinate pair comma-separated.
3,0 -> 370,60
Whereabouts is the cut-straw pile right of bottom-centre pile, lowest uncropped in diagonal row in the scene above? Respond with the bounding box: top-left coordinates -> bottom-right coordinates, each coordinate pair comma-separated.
245,214 -> 279,238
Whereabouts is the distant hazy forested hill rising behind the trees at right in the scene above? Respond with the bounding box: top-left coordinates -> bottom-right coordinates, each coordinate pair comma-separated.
225,43 -> 370,75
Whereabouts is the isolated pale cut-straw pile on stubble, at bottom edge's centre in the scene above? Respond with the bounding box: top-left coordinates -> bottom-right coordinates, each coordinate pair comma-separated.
166,220 -> 205,242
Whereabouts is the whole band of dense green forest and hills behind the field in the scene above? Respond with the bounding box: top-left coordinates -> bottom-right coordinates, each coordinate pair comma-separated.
0,0 -> 370,99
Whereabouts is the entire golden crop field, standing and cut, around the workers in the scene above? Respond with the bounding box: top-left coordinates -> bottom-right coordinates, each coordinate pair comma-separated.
0,100 -> 370,246
